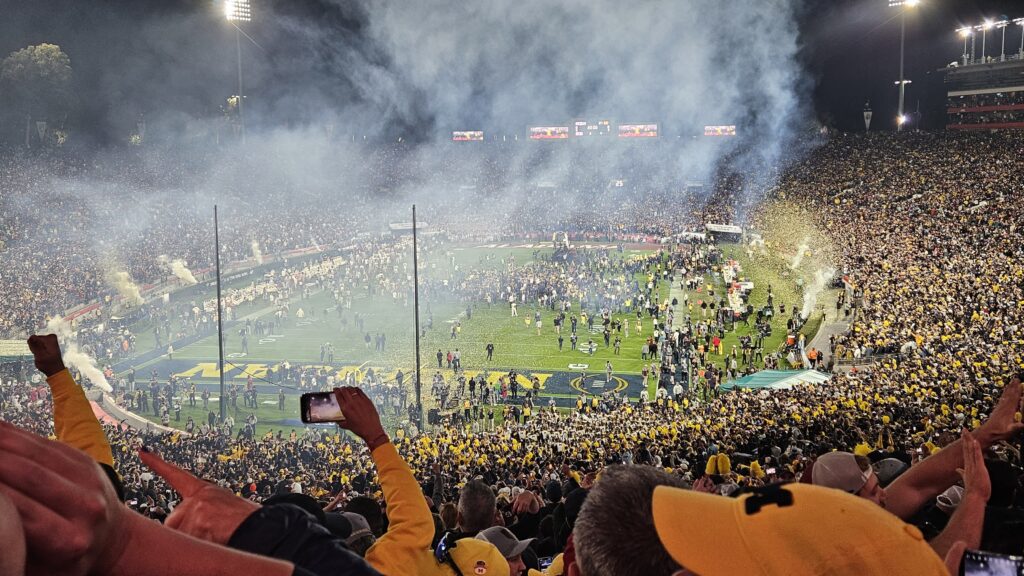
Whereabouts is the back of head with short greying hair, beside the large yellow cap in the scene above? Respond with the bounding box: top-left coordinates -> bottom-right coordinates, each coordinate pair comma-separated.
571,466 -> 685,576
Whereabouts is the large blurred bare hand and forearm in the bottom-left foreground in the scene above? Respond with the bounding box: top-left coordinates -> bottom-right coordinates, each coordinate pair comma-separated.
0,416 -> 299,576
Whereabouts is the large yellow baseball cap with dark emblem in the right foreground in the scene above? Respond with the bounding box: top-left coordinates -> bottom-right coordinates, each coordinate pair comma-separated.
653,484 -> 948,576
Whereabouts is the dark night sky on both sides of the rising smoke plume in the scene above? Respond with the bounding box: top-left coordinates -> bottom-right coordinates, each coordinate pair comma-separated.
0,0 -> 1024,142
